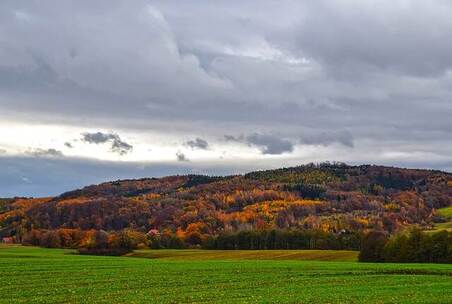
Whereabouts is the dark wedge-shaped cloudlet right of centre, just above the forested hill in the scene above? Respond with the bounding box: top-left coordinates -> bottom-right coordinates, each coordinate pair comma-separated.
245,133 -> 294,154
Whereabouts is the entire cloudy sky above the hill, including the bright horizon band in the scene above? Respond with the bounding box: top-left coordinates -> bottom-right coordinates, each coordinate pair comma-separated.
0,0 -> 452,197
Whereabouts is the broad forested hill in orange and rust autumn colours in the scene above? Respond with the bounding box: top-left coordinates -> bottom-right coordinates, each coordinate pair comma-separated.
0,163 -> 452,245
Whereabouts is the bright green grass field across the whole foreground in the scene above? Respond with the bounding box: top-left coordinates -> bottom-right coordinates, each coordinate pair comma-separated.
0,246 -> 452,303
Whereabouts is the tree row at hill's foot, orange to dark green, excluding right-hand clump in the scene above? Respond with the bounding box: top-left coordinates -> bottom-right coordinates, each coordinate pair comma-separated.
22,229 -> 361,254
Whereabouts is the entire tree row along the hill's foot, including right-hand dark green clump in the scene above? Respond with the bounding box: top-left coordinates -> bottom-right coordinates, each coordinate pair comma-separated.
15,228 -> 452,263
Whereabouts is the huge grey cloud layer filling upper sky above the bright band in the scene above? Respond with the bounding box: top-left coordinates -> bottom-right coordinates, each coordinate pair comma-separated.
0,1 -> 452,138
